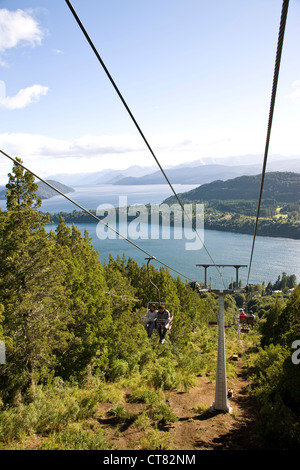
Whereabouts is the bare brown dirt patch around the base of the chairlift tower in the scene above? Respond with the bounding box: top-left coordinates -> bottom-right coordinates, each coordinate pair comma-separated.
170,377 -> 255,450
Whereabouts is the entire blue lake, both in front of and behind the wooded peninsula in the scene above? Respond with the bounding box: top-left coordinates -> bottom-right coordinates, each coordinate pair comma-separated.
0,185 -> 300,288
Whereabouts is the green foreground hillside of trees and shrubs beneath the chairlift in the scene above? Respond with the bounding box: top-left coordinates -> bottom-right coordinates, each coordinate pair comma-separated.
0,160 -> 300,450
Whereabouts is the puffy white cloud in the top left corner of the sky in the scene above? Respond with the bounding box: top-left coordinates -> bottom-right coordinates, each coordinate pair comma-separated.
0,8 -> 44,65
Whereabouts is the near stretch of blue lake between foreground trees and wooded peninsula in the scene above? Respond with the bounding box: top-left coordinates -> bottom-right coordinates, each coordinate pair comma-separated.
49,223 -> 300,288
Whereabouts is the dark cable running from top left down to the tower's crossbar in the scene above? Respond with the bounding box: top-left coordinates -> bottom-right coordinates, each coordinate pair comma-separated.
66,0 -> 225,287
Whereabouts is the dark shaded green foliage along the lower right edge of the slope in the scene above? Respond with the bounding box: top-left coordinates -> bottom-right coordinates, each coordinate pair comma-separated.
253,287 -> 300,449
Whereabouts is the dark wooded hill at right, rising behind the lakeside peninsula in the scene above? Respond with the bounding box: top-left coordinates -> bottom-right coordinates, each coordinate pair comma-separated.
164,172 -> 300,203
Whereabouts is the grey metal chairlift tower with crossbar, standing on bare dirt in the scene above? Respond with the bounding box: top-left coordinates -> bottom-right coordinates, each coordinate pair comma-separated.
196,264 -> 247,413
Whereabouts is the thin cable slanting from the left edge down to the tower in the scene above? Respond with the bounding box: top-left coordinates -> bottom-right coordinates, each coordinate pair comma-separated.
0,149 -> 193,282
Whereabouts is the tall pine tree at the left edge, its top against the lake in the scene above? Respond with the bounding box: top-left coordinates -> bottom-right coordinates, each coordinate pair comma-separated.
0,165 -> 68,395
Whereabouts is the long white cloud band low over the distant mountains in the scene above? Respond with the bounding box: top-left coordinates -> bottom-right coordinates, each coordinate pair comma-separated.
0,123 -> 299,184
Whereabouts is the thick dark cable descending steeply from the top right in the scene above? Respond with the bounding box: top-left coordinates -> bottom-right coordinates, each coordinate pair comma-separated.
247,0 -> 289,285
